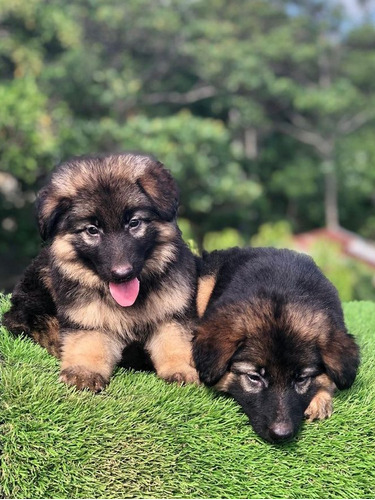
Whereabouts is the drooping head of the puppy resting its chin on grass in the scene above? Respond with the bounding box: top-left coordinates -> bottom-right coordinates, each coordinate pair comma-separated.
193,301 -> 359,442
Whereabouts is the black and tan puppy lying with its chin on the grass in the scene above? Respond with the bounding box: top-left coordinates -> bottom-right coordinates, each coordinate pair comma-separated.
193,248 -> 359,442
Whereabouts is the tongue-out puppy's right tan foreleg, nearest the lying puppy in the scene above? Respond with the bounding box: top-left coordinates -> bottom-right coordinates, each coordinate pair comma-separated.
146,321 -> 199,383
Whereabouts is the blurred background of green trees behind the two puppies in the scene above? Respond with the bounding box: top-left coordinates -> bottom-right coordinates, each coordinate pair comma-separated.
0,0 -> 375,300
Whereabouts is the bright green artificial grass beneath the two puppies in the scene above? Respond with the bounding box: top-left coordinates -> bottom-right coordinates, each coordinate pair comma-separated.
0,292 -> 375,498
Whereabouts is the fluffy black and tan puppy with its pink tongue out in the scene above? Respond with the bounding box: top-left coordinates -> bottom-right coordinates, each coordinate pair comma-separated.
4,154 -> 198,392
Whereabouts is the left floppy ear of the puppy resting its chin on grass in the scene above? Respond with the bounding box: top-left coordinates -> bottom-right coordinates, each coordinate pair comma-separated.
193,317 -> 245,385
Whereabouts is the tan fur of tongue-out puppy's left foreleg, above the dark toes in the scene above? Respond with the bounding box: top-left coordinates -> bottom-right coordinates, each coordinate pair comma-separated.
61,330 -> 122,380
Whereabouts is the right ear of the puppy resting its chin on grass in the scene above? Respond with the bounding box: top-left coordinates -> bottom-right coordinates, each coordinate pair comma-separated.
321,329 -> 359,389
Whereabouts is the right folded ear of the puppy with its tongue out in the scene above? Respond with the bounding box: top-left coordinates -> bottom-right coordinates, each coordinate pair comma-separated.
138,161 -> 179,221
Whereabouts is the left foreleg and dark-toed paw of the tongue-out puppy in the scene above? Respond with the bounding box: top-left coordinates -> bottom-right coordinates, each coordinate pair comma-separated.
60,330 -> 123,392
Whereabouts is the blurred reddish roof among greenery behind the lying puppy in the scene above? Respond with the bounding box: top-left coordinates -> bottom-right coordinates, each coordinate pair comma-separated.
293,227 -> 375,269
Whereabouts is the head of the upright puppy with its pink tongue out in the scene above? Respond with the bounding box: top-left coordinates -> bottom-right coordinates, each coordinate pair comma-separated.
37,154 -> 180,302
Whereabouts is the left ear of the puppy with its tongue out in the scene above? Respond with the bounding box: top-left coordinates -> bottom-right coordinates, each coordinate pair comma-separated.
36,185 -> 71,241
